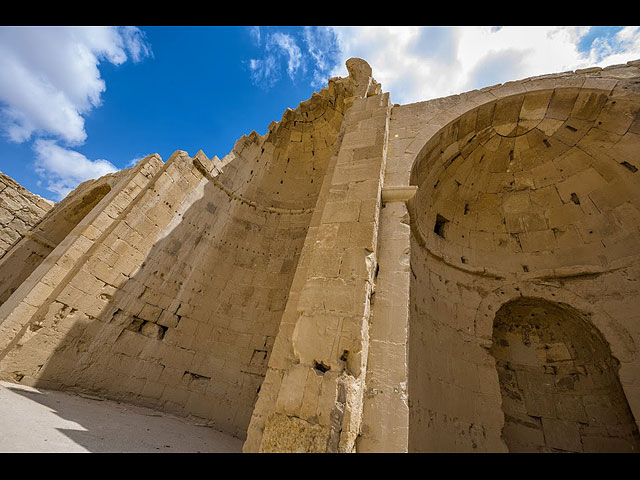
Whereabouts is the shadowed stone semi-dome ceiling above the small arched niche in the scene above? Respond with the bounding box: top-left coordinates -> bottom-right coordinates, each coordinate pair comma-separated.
413,84 -> 640,275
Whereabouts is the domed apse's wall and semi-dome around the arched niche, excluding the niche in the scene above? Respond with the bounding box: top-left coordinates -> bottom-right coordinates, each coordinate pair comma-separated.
408,65 -> 640,451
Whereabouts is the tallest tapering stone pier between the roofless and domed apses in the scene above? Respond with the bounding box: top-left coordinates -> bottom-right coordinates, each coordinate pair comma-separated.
244,78 -> 391,452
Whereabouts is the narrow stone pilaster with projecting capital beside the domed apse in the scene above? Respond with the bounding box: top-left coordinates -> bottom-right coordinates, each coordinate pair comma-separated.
357,186 -> 417,453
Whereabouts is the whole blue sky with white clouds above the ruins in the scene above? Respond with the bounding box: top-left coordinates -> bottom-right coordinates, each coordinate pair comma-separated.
0,26 -> 640,201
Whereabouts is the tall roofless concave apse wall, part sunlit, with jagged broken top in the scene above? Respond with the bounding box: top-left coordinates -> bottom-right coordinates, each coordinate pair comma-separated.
0,60 -> 368,437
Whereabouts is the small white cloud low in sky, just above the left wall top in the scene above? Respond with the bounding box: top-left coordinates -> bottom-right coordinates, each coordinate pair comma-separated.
33,139 -> 118,200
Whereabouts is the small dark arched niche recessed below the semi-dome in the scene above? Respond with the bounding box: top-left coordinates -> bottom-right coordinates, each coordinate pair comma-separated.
491,297 -> 640,452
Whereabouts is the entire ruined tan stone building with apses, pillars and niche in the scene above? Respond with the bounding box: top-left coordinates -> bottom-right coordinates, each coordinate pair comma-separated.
0,59 -> 640,452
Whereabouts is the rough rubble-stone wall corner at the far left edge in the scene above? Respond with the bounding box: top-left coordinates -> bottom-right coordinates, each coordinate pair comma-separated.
0,172 -> 55,258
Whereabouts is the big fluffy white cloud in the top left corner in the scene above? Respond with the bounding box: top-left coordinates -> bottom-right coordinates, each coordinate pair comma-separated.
0,27 -> 151,145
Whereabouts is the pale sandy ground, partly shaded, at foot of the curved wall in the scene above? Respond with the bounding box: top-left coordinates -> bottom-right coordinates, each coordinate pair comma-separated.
0,382 -> 243,453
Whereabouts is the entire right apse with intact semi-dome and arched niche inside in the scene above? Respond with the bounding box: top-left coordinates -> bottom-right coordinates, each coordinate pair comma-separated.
405,66 -> 640,452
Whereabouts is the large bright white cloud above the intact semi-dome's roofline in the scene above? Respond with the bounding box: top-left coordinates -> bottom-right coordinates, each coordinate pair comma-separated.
332,27 -> 640,104
